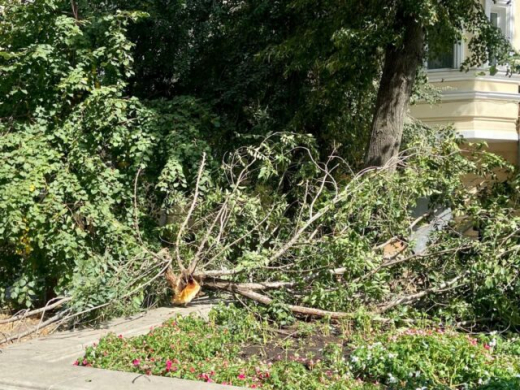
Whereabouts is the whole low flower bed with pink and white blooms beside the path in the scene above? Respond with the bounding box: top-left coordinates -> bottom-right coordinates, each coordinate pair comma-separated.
75,306 -> 520,390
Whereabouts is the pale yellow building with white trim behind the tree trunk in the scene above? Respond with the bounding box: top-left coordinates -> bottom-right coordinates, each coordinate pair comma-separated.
411,0 -> 520,165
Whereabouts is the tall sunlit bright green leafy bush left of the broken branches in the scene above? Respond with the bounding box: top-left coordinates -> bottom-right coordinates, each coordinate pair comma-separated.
0,1 -> 218,308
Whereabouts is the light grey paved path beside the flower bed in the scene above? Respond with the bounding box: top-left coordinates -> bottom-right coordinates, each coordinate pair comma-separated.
0,300 -> 244,390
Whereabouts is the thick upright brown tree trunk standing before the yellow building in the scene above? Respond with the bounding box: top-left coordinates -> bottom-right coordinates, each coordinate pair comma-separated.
365,16 -> 424,167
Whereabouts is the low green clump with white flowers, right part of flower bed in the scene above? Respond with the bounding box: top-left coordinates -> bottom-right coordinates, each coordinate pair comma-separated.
350,329 -> 520,389
